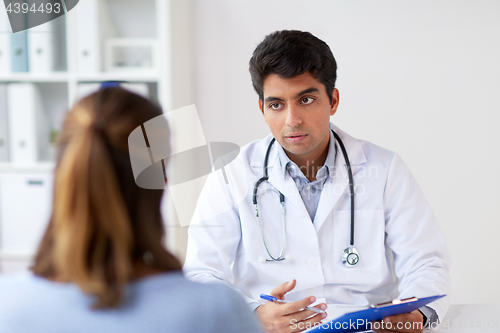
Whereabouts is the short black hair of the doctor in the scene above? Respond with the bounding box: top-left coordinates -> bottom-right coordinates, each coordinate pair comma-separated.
249,30 -> 337,103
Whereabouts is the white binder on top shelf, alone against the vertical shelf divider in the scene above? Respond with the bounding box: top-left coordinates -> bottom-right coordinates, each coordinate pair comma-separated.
75,0 -> 115,74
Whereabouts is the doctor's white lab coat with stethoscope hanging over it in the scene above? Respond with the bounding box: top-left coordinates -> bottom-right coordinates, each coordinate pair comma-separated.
184,124 -> 450,319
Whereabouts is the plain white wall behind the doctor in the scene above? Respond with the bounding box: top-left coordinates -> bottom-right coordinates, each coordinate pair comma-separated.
186,0 -> 500,303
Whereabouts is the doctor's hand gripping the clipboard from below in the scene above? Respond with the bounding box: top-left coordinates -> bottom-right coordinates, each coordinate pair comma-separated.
372,310 -> 424,333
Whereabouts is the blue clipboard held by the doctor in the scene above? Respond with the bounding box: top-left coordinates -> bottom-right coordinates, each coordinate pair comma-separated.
308,295 -> 446,333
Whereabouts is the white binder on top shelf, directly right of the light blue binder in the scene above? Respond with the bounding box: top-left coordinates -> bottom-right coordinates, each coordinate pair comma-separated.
28,21 -> 56,73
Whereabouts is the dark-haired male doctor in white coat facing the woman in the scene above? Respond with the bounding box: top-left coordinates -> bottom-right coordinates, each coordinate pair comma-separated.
184,31 -> 450,332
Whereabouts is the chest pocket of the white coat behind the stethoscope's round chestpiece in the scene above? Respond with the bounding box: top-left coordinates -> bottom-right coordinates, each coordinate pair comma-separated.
333,210 -> 385,274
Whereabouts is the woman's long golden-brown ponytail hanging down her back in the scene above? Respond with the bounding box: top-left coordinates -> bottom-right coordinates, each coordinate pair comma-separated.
35,103 -> 133,308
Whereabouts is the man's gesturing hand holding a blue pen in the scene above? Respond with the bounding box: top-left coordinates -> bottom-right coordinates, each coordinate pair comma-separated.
256,280 -> 326,333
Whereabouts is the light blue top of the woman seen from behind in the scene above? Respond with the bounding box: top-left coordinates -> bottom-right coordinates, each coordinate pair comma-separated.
0,272 -> 260,333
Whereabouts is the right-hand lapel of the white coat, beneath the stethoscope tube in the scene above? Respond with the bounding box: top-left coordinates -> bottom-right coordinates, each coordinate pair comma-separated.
314,124 -> 367,230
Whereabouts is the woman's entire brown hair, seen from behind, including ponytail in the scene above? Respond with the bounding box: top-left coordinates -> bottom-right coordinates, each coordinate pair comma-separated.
32,88 -> 181,308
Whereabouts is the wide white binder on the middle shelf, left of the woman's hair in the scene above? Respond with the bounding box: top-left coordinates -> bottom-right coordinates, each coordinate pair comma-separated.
7,83 -> 50,165
